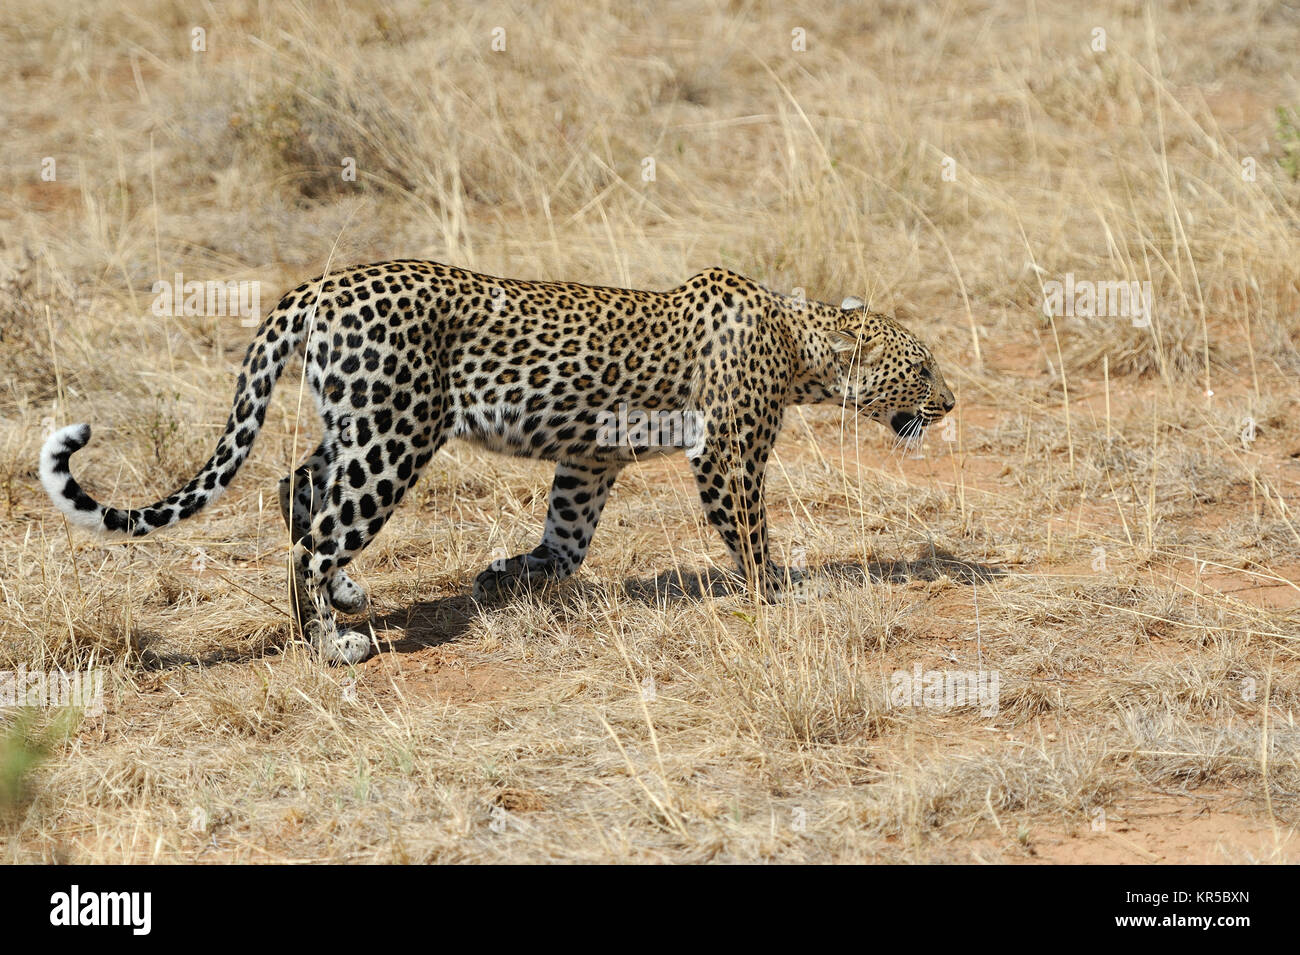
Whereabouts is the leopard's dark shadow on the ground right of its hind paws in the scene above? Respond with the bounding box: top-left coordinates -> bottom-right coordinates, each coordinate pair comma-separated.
366,548 -> 1006,654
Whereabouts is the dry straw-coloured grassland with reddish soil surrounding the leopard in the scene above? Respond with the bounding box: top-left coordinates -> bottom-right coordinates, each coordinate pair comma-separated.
0,0 -> 1300,861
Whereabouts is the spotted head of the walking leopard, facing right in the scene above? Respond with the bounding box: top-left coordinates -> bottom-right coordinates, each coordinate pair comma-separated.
827,299 -> 957,438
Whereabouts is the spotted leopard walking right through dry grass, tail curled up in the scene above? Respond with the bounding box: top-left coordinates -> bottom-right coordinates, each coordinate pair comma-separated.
39,259 -> 956,664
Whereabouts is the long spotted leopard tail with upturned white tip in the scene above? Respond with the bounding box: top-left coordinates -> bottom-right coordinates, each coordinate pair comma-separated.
40,288 -> 316,537
